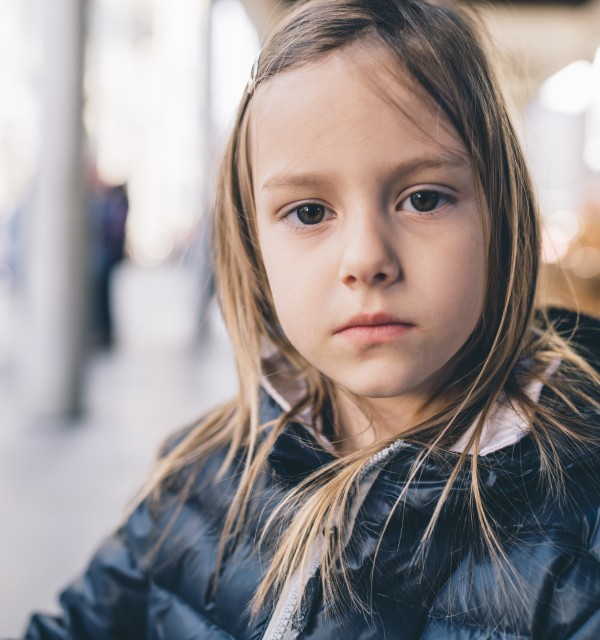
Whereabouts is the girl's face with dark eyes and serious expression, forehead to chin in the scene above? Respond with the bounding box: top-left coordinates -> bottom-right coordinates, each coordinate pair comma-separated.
251,44 -> 486,418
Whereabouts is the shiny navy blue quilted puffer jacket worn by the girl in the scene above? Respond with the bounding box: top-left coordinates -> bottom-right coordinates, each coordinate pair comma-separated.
16,312 -> 600,640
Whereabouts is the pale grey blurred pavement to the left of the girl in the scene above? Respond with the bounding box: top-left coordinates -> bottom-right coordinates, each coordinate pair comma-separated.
0,266 -> 235,638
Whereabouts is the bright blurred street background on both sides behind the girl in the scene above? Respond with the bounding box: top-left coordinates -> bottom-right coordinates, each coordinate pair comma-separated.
0,0 -> 600,636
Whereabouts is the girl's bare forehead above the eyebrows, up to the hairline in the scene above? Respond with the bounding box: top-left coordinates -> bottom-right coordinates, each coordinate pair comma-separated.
250,42 -> 469,191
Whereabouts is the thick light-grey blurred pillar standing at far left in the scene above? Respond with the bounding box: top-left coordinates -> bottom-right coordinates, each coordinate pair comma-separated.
20,0 -> 86,418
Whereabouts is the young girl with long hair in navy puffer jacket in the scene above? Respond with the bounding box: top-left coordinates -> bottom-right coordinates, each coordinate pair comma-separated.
19,0 -> 600,640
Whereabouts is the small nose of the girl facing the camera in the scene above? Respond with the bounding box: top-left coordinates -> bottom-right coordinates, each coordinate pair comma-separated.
339,211 -> 402,286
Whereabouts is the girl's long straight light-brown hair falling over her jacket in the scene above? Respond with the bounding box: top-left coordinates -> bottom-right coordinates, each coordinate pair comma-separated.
137,0 -> 598,620
